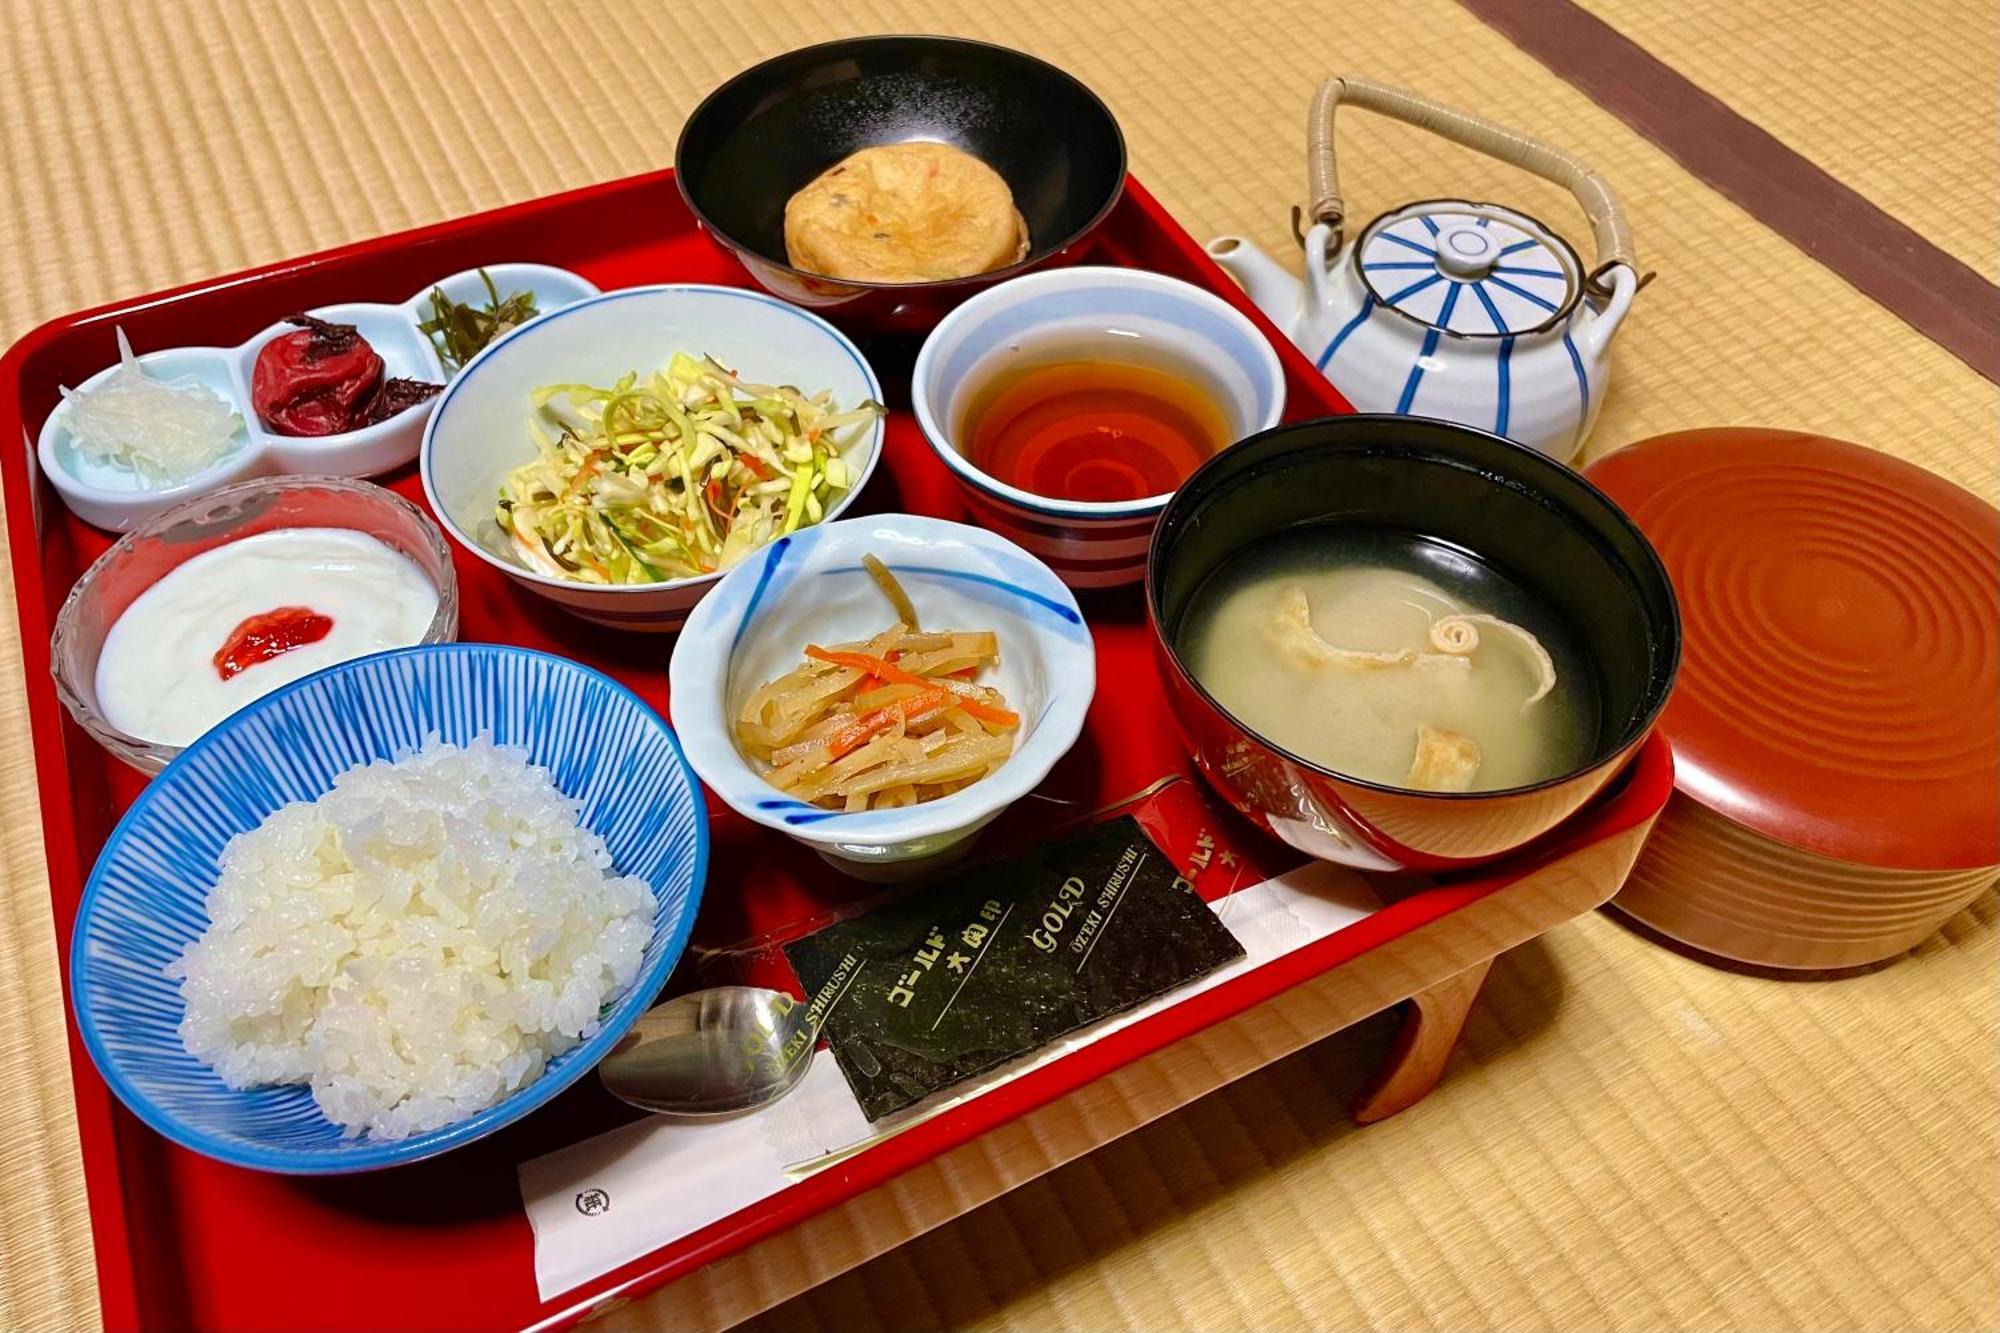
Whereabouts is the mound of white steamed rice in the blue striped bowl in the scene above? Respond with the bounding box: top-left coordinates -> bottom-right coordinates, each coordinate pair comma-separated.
168,739 -> 654,1139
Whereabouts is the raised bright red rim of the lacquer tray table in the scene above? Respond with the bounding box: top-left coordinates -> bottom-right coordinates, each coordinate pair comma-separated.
0,168 -> 1672,1329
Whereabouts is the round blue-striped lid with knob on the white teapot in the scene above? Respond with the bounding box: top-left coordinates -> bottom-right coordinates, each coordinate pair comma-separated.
1354,198 -> 1584,338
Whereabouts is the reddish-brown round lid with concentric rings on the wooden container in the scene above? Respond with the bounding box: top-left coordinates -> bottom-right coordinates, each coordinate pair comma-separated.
1588,428 -> 2000,871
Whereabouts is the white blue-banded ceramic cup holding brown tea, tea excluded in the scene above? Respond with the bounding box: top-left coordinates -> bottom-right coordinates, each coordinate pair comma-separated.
910,266 -> 1284,588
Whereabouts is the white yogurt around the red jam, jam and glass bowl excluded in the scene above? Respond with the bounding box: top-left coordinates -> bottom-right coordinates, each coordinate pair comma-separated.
98,528 -> 438,745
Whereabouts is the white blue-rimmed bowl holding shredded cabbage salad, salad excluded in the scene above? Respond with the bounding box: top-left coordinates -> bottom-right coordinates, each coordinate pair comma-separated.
422,282 -> 882,632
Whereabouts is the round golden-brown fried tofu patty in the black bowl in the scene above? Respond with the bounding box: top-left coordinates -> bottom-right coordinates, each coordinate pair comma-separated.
784,142 -> 1028,282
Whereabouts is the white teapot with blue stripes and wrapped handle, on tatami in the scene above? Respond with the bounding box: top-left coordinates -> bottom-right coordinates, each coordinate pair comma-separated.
1208,74 -> 1642,462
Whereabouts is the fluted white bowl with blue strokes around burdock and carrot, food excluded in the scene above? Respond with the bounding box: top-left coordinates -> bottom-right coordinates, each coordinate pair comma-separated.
668,514 -> 1098,881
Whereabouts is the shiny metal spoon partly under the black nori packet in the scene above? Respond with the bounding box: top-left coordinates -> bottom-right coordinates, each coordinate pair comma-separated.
598,987 -> 818,1117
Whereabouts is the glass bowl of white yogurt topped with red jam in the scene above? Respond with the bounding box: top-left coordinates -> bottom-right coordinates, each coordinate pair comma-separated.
50,476 -> 458,773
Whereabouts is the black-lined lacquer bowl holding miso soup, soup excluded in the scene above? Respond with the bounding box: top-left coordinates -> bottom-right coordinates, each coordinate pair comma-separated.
1146,416 -> 1680,873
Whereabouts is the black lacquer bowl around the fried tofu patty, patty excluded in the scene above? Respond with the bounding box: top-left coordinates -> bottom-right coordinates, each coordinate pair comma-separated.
674,36 -> 1126,334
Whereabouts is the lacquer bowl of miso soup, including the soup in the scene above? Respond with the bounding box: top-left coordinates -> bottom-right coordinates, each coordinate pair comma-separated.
1146,416 -> 1680,873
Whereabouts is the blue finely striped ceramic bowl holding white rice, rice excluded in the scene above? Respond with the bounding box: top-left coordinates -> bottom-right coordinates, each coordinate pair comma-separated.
70,644 -> 708,1175
